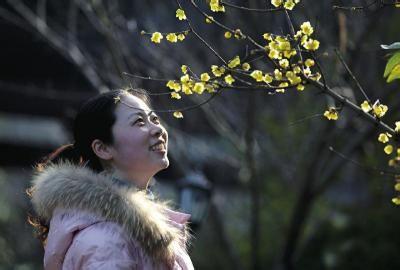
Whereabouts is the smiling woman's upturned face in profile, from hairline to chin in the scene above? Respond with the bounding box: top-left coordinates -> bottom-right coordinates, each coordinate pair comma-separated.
110,94 -> 169,187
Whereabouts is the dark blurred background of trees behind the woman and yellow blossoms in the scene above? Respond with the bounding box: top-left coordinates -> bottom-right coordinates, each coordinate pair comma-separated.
0,0 -> 400,270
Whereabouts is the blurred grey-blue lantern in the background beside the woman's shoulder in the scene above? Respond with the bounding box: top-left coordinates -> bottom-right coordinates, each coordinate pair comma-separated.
179,171 -> 211,231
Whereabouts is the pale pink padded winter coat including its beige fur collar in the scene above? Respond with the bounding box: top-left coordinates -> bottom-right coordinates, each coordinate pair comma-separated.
32,163 -> 194,270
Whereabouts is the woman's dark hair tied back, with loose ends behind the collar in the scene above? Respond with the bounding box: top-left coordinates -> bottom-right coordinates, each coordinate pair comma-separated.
27,88 -> 151,245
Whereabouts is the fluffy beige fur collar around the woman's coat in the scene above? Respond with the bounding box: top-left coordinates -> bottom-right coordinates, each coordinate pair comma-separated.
32,163 -> 185,262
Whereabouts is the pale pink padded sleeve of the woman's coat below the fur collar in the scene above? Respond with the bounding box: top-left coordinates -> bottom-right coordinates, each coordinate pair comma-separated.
62,222 -> 140,270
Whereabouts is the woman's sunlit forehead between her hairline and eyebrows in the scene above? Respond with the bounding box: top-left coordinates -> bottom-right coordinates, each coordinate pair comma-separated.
115,95 -> 151,119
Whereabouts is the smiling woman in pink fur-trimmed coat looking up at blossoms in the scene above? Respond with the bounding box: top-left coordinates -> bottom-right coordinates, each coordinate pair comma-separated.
30,87 -> 193,270
